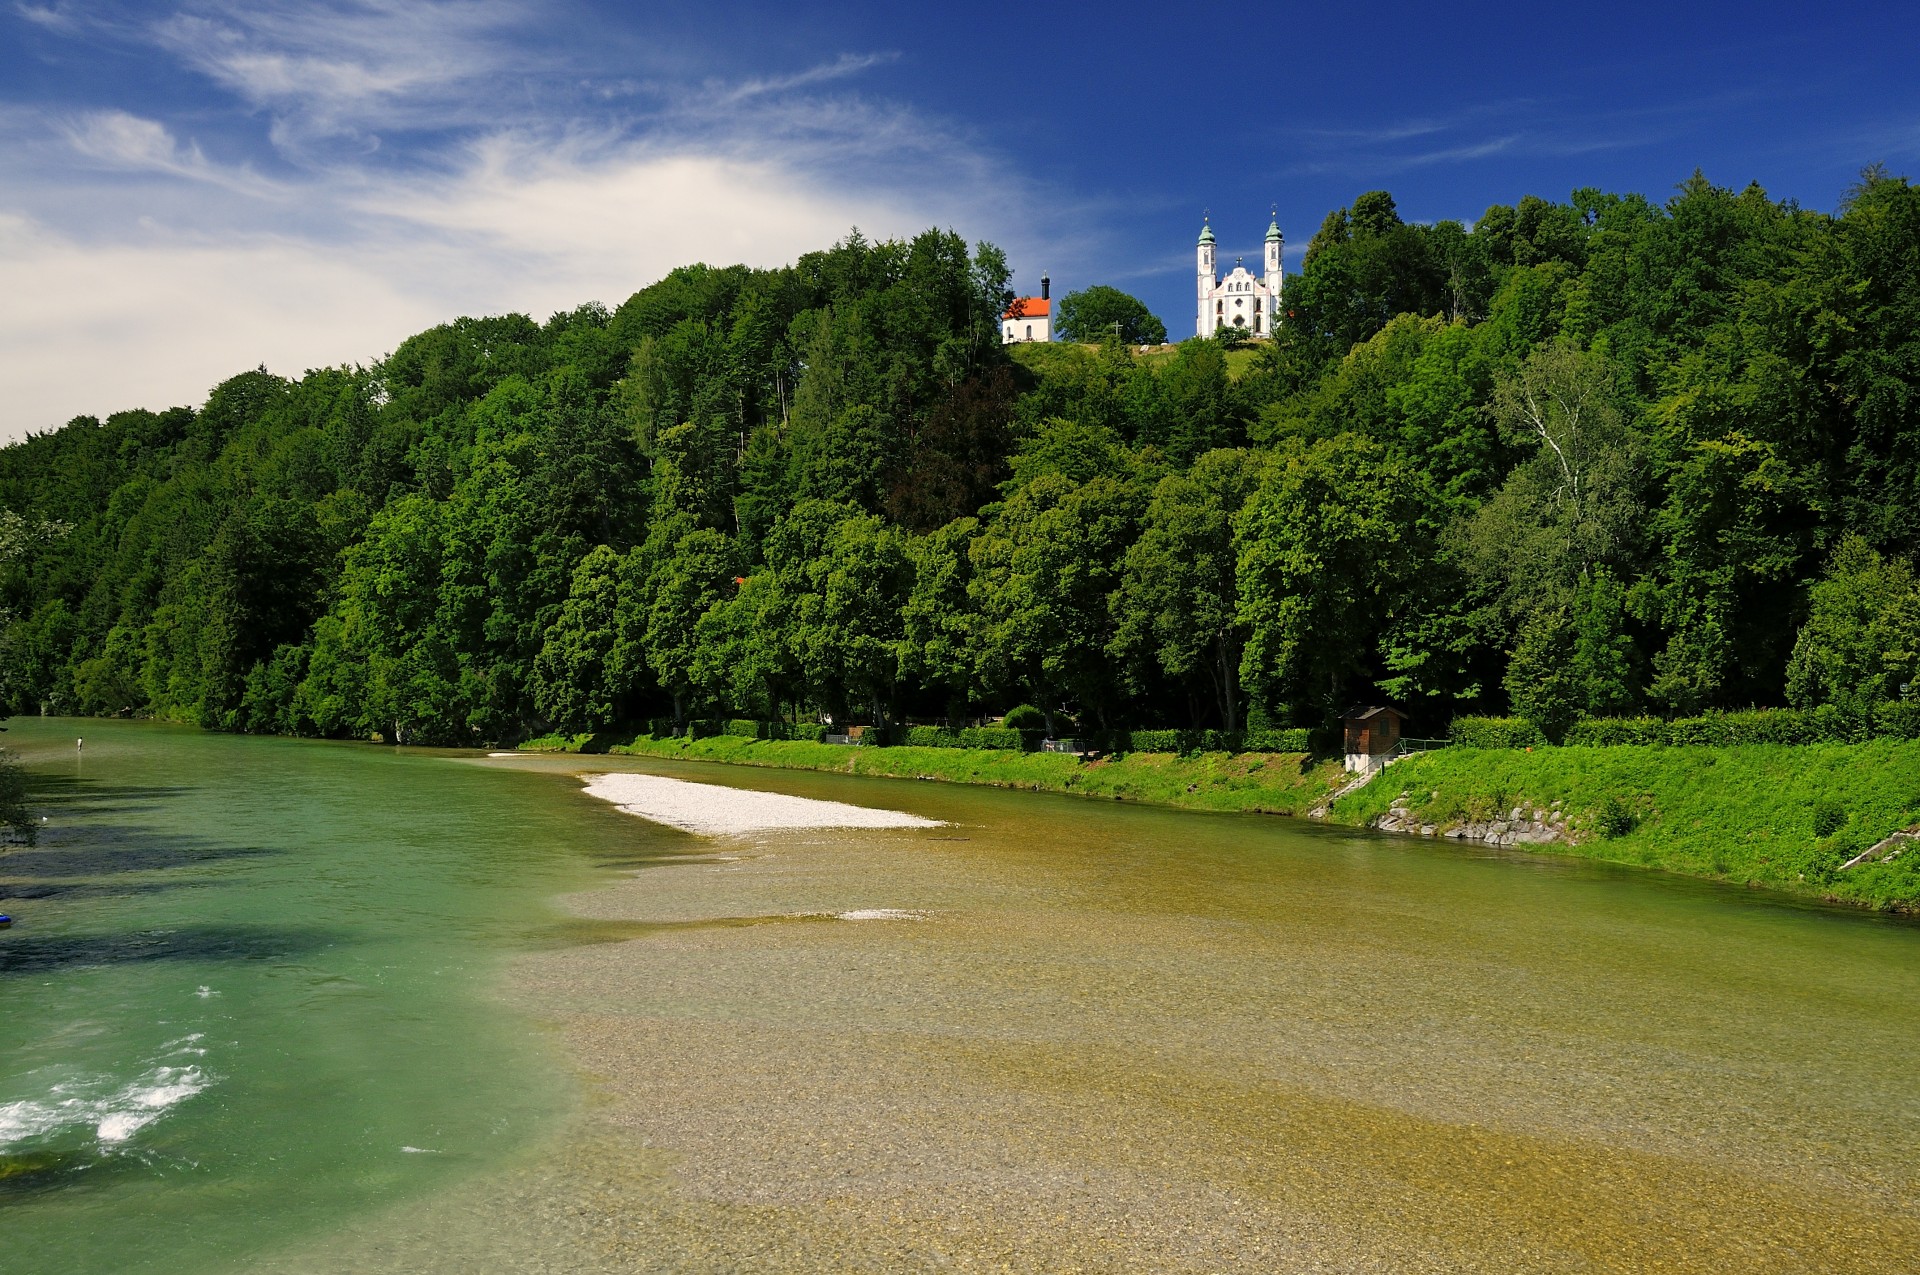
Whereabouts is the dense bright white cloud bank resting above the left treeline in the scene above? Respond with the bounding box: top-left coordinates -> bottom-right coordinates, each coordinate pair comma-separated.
0,138 -> 983,438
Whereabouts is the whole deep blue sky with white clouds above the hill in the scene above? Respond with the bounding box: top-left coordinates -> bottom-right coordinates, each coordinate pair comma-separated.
0,0 -> 1920,438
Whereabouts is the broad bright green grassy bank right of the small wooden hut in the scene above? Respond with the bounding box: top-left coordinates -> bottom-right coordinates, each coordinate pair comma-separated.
1331,739 -> 1920,910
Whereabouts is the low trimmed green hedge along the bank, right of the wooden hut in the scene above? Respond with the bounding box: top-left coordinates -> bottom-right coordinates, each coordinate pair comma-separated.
1450,701 -> 1920,749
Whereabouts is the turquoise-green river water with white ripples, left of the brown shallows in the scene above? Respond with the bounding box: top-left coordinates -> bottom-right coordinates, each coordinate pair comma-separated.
0,718 -> 614,1275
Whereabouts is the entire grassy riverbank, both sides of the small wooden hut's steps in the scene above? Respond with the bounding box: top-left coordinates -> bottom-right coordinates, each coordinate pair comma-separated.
510,735 -> 1920,914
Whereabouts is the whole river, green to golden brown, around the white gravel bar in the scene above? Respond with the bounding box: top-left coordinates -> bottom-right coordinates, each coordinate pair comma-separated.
0,720 -> 1920,1275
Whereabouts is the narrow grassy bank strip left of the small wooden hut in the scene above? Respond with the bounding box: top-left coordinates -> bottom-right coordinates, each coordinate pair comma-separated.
524,735 -> 1342,814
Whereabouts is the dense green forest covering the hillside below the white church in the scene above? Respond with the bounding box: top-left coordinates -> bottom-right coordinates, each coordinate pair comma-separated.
0,169 -> 1920,743
